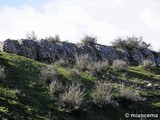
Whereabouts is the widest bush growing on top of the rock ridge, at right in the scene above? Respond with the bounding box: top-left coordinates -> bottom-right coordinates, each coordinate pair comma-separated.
112,36 -> 151,49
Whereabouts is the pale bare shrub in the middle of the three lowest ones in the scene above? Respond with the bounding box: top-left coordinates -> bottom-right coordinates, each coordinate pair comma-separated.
93,81 -> 112,107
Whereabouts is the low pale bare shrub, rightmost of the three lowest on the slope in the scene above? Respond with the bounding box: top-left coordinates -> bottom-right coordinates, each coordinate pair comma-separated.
120,84 -> 142,101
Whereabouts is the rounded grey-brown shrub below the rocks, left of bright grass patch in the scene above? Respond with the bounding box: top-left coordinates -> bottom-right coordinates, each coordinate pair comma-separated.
40,65 -> 58,82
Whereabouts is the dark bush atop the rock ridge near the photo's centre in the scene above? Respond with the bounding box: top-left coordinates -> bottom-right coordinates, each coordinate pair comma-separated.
81,35 -> 97,46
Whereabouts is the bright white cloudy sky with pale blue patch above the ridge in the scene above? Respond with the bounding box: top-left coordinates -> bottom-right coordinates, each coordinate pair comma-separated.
0,0 -> 160,50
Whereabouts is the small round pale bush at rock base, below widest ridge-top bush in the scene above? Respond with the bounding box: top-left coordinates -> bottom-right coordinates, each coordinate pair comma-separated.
112,59 -> 127,71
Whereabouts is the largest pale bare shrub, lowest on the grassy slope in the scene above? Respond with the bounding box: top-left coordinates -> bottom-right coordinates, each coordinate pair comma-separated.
59,83 -> 85,112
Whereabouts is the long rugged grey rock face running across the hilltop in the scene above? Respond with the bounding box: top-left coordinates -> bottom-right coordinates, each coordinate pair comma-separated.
0,39 -> 160,66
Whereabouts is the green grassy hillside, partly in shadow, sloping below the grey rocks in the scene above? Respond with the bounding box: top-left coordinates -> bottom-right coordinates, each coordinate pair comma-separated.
0,52 -> 160,120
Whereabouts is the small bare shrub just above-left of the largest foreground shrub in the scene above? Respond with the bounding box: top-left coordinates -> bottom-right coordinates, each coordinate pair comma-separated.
50,80 -> 63,95
